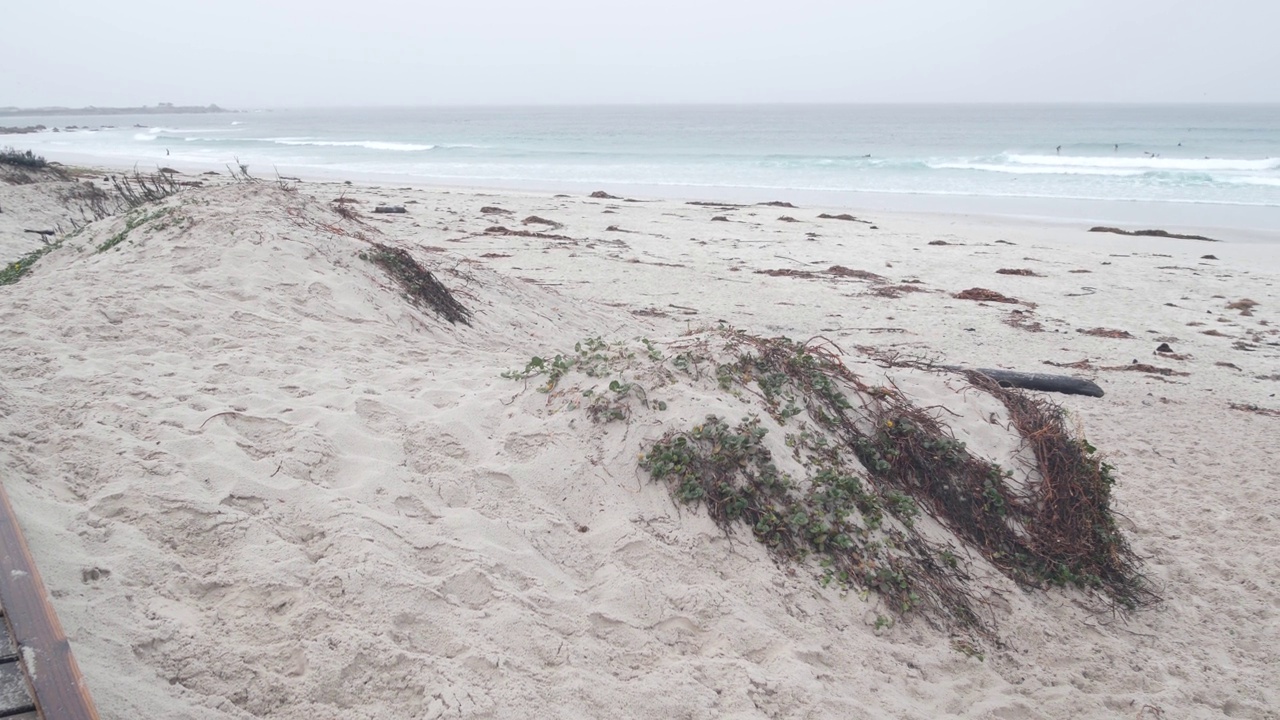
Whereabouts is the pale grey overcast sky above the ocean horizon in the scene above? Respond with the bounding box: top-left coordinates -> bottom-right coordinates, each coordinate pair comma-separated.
0,0 -> 1280,108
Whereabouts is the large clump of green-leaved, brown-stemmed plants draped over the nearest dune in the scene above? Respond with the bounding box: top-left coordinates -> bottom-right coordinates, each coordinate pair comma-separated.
641,331 -> 1157,633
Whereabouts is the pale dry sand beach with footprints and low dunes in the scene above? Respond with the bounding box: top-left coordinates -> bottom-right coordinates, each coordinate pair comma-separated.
0,165 -> 1280,720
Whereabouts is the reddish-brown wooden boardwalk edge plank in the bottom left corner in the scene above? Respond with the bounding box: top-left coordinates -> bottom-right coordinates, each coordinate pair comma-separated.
0,483 -> 99,720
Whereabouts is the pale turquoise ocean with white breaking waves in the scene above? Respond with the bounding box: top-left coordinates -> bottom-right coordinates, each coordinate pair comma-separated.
10,105 -> 1280,229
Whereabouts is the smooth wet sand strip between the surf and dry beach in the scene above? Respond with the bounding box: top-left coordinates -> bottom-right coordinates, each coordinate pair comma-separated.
12,152 -> 1280,257
